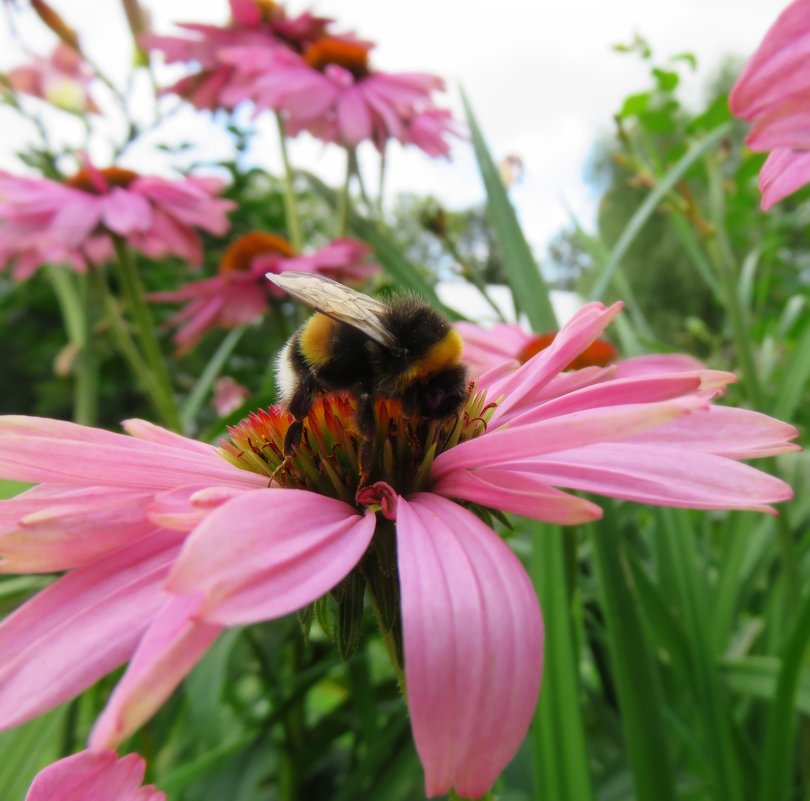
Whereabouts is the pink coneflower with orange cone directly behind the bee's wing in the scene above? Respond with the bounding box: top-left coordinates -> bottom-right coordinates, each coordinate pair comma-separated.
149,231 -> 379,354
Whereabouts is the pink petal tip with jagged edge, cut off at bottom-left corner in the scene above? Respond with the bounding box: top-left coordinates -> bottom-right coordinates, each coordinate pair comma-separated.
25,750 -> 166,801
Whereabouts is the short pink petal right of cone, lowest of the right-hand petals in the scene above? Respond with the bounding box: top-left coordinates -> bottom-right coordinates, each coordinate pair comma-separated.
433,467 -> 602,526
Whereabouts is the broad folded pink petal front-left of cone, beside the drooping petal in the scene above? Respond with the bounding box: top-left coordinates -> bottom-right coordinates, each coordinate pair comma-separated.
167,489 -> 375,626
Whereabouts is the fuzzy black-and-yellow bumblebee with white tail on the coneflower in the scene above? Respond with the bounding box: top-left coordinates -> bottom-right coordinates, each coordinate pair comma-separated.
267,271 -> 467,455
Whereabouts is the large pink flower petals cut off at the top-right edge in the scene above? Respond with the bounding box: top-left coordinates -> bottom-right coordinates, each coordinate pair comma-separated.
729,0 -> 810,209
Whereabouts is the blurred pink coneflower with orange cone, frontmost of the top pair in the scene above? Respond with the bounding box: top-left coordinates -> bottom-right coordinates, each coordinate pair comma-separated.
222,36 -> 455,156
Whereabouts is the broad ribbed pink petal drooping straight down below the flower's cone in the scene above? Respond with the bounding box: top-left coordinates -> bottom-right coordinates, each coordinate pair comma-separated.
397,493 -> 543,798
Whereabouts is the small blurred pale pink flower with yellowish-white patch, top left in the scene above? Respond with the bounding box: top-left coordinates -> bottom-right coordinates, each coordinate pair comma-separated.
7,42 -> 99,114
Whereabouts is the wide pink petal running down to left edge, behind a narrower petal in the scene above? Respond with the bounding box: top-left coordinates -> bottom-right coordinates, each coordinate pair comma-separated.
0,531 -> 182,728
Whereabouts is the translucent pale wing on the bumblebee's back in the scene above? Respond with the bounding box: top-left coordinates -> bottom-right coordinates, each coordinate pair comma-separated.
267,270 -> 396,348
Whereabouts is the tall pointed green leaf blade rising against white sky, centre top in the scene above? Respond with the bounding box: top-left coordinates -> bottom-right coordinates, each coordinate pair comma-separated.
461,93 -> 559,332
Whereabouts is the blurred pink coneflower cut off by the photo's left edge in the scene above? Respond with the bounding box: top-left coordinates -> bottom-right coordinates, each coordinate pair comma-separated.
0,164 -> 235,280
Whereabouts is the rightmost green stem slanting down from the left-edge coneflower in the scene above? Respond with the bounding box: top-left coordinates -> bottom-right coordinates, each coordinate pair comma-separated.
108,236 -> 183,431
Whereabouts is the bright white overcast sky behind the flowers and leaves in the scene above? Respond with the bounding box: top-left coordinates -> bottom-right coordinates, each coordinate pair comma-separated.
0,0 -> 787,250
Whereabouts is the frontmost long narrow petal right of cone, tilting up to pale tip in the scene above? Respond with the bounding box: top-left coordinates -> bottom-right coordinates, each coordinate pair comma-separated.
432,397 -> 708,480
